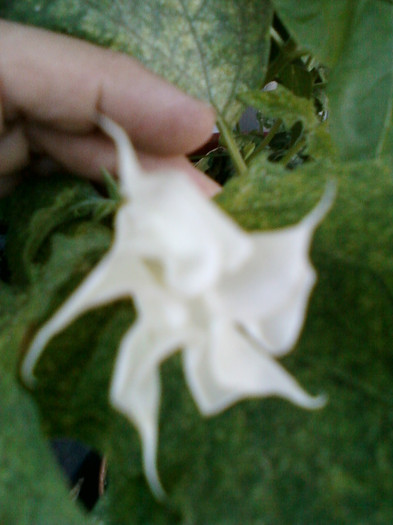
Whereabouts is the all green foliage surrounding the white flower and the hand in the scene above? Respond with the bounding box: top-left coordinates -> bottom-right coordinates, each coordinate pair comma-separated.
0,0 -> 393,525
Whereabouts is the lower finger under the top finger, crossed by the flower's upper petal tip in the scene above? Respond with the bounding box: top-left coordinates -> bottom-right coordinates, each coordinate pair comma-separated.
27,126 -> 220,197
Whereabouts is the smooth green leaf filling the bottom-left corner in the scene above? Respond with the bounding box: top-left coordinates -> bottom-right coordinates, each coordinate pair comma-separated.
0,371 -> 93,525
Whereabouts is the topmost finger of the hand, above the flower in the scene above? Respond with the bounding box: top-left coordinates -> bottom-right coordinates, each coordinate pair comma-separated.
0,21 -> 214,155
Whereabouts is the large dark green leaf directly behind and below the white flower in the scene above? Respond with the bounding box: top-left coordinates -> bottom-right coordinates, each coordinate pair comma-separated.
0,158 -> 393,525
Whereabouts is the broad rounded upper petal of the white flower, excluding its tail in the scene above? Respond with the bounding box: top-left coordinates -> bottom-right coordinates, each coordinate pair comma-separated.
120,172 -> 252,296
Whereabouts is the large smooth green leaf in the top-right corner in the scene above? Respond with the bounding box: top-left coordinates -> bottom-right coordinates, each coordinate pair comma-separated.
274,0 -> 393,160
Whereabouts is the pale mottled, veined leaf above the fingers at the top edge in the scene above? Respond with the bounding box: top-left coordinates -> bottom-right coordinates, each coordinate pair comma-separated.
0,0 -> 272,120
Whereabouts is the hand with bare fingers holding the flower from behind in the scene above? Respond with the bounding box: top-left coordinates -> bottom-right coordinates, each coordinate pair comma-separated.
0,20 -> 218,196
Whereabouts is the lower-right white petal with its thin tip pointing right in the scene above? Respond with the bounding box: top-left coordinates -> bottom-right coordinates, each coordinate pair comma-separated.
184,322 -> 324,415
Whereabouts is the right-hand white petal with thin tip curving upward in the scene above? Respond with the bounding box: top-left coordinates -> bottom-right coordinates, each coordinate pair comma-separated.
213,189 -> 333,354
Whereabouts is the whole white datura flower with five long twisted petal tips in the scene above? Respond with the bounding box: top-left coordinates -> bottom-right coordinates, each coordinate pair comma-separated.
22,115 -> 332,497
